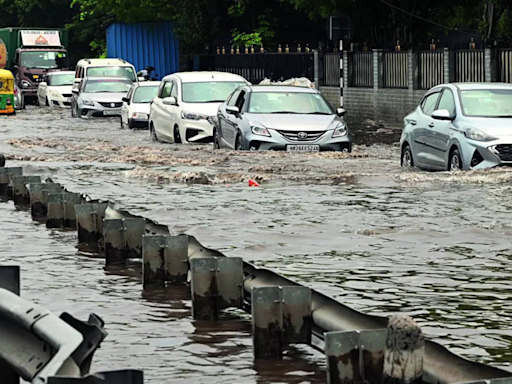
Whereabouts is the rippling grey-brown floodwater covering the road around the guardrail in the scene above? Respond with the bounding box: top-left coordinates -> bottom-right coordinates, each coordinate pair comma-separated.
0,108 -> 512,383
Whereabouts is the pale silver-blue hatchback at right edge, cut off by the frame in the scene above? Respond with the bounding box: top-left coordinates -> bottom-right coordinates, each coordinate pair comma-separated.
400,83 -> 512,170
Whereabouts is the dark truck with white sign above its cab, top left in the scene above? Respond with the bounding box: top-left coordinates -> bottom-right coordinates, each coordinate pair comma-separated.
0,27 -> 69,104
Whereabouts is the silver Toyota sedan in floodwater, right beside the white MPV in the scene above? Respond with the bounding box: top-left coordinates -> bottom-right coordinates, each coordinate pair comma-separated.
213,85 -> 352,152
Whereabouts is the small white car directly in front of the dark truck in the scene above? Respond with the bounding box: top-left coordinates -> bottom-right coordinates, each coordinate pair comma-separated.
37,71 -> 75,108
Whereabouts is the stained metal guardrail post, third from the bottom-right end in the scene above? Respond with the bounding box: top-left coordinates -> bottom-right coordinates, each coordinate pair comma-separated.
190,257 -> 243,320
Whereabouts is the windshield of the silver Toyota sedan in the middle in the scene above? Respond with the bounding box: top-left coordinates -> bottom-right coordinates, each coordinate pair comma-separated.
249,91 -> 334,115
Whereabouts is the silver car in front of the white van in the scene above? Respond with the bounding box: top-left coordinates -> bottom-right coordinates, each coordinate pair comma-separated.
71,77 -> 132,117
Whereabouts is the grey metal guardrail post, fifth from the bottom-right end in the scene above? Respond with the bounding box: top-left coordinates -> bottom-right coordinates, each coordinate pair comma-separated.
103,219 -> 146,265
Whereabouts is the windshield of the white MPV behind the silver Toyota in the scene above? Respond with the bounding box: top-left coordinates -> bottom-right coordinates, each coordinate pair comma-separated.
182,81 -> 245,103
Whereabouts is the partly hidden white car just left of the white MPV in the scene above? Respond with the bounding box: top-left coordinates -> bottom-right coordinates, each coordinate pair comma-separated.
121,81 -> 160,128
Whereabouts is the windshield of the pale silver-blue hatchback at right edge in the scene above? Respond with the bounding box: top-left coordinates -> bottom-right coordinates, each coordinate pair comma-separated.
460,89 -> 512,117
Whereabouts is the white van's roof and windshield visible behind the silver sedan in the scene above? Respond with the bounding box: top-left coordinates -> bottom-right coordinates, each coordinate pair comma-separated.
75,59 -> 138,83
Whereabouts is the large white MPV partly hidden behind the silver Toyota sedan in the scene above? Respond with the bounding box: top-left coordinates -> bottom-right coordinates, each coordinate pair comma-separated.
149,72 -> 249,143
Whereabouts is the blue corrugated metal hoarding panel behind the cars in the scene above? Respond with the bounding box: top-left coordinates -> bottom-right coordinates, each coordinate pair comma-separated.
107,21 -> 179,79
